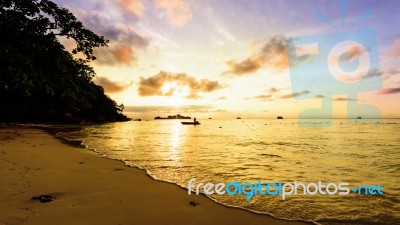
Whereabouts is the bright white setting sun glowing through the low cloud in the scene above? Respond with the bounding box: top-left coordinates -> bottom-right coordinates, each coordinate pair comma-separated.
161,82 -> 190,107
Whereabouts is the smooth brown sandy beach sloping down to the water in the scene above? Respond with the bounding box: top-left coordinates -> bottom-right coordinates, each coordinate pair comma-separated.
0,127 -> 307,225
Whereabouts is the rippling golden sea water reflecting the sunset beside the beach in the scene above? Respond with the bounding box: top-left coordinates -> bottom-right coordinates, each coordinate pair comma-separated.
60,119 -> 400,225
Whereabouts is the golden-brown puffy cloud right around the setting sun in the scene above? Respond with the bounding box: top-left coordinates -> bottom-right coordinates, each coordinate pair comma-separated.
138,71 -> 223,99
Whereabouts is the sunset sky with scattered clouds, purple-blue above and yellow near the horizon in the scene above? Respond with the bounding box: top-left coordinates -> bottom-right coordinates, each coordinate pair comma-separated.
55,0 -> 400,118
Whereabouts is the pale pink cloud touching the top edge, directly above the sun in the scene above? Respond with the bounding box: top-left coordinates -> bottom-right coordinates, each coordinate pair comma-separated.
155,0 -> 192,27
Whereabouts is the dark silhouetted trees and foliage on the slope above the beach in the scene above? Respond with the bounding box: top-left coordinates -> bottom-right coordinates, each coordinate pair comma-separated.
0,0 -> 127,123
